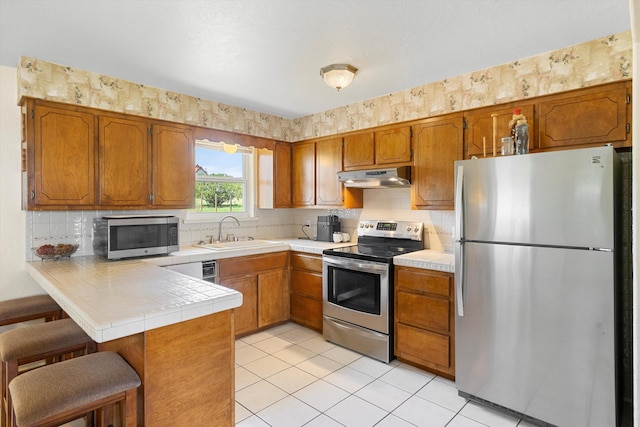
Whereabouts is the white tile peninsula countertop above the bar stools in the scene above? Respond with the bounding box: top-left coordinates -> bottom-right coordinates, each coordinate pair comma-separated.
26,256 -> 242,342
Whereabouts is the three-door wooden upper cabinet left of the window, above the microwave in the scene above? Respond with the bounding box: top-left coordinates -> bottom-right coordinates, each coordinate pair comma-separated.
22,98 -> 195,210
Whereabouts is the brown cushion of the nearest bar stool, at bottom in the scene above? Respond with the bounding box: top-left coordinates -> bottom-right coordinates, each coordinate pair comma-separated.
9,351 -> 140,426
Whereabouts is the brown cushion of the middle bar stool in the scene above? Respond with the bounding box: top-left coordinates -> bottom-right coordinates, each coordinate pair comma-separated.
0,319 -> 91,360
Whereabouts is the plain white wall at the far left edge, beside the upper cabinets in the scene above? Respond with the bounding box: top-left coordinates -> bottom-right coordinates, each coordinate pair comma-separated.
0,66 -> 43,300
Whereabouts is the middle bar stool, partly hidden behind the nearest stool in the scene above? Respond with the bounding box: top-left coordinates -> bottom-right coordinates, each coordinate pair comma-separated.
0,319 -> 96,427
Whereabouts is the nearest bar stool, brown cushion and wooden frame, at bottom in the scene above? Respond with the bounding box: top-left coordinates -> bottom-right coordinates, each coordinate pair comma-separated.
9,351 -> 141,427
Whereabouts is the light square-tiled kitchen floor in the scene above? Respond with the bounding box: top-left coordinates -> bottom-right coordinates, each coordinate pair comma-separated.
236,323 -> 533,427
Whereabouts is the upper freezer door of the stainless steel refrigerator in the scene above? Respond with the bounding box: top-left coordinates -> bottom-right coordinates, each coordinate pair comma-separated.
456,147 -> 618,248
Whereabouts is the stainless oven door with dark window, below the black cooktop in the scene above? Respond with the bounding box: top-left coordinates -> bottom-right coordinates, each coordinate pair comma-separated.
322,255 -> 390,334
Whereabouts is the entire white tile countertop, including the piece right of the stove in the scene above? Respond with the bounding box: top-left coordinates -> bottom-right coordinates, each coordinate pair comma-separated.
26,238 -> 453,342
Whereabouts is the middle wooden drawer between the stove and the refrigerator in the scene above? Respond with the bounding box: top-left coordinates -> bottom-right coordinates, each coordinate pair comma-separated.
396,291 -> 451,334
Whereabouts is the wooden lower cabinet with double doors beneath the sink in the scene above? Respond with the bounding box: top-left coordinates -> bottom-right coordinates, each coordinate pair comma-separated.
216,251 -> 290,336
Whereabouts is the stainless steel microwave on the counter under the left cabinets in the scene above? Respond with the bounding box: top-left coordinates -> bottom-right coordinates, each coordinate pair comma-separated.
93,215 -> 180,259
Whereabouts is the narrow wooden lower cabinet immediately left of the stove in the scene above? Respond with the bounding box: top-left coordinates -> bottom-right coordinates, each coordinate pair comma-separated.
291,252 -> 322,332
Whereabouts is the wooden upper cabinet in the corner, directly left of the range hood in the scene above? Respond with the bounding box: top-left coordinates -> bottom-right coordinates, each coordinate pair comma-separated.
291,137 -> 362,208
